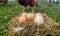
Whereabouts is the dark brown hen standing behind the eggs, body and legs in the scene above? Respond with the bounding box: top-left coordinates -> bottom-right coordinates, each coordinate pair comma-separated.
18,0 -> 37,12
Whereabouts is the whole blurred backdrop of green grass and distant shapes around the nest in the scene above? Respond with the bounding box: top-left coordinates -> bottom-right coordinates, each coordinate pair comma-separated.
0,0 -> 60,36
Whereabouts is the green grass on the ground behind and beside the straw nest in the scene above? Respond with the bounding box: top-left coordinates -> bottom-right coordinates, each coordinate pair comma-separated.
0,2 -> 60,36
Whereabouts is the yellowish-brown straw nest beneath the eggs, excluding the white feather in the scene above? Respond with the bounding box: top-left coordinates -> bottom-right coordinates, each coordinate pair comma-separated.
9,14 -> 60,36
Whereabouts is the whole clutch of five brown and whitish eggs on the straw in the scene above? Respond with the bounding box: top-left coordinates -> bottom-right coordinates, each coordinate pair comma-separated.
18,13 -> 44,25
